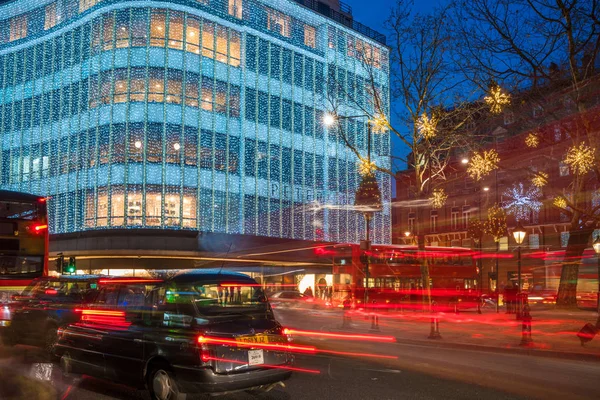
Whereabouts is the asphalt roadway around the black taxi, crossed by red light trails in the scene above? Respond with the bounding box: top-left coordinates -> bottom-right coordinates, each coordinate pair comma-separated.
0,310 -> 600,400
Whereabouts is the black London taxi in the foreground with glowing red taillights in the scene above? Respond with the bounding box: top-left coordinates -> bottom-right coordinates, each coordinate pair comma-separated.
56,270 -> 293,400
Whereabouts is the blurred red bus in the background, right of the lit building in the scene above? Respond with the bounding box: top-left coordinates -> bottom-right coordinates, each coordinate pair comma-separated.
333,245 -> 481,311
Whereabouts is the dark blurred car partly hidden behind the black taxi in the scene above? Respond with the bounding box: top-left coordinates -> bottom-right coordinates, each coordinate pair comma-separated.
2,275 -> 100,355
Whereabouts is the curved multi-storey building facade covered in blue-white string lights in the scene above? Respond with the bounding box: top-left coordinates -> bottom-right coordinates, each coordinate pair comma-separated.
0,0 -> 391,253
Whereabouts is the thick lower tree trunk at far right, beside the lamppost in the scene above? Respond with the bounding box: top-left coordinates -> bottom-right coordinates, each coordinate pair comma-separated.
556,228 -> 594,308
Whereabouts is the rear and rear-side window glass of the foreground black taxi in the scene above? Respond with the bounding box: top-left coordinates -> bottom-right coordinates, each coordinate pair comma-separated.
164,283 -> 267,315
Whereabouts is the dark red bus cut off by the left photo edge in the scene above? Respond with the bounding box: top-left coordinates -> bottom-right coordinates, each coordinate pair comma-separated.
0,190 -> 48,303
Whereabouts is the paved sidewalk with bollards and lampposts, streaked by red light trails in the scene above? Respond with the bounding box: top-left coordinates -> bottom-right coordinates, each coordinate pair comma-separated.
278,310 -> 600,361
